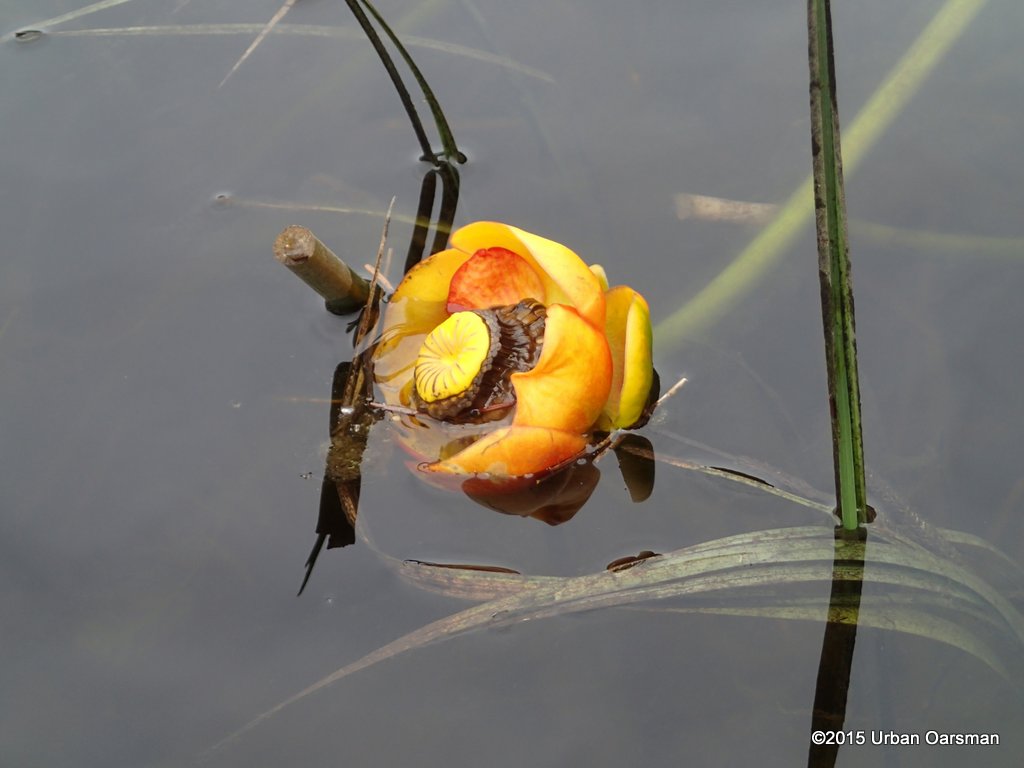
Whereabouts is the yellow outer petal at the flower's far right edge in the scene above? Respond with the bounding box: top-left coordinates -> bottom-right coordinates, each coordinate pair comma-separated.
599,286 -> 654,429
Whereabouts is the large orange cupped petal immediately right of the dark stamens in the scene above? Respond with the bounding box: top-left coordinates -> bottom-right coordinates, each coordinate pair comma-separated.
512,304 -> 611,434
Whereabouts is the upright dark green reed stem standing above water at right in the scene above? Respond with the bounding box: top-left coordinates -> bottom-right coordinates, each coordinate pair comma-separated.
807,0 -> 867,530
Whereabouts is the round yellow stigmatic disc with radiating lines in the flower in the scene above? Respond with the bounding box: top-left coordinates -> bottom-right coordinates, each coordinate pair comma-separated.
414,312 -> 492,403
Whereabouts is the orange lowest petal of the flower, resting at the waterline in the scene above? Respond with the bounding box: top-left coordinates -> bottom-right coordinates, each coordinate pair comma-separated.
424,426 -> 587,478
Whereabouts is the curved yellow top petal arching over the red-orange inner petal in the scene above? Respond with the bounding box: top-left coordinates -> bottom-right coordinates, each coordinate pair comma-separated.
451,221 -> 604,328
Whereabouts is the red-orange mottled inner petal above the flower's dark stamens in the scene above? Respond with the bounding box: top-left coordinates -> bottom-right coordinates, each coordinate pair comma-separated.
447,246 -> 546,312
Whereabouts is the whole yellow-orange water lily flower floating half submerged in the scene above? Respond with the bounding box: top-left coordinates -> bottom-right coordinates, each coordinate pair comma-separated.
374,221 -> 653,479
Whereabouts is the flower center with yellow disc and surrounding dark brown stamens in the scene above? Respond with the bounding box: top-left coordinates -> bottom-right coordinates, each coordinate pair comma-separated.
413,299 -> 546,423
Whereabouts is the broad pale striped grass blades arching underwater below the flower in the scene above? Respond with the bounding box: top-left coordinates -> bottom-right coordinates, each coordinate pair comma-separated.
212,526 -> 1024,750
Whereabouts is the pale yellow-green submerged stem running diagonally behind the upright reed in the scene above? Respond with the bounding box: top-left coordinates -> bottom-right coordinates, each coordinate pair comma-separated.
654,0 -> 988,349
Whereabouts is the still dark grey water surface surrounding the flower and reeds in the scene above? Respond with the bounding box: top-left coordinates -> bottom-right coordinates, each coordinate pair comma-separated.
0,0 -> 1024,768
